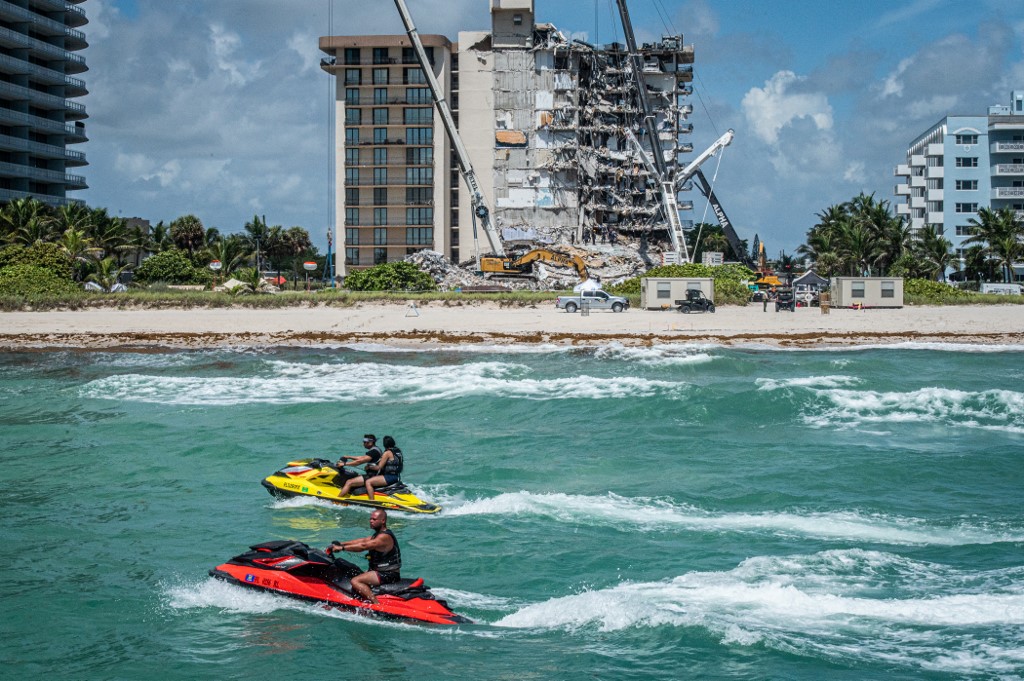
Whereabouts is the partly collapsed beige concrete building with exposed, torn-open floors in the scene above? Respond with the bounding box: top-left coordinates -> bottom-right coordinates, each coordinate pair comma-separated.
319,0 -> 693,279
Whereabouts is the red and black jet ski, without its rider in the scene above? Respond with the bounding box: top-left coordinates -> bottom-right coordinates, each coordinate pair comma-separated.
210,540 -> 470,625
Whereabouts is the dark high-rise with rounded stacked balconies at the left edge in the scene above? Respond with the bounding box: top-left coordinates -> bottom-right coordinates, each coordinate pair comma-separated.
0,0 -> 88,205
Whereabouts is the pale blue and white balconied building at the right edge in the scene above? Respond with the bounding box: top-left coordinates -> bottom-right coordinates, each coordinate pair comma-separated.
895,91 -> 1024,266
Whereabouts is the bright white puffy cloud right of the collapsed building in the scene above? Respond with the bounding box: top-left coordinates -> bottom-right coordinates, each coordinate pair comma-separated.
741,71 -> 833,145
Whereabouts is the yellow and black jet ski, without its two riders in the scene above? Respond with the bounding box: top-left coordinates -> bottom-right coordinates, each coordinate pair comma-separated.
262,459 -> 441,513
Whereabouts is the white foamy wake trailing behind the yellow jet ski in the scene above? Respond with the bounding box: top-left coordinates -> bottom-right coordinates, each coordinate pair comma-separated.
442,492 -> 1024,546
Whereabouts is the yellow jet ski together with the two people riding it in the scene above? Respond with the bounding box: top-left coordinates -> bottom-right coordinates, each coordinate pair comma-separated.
262,435 -> 441,513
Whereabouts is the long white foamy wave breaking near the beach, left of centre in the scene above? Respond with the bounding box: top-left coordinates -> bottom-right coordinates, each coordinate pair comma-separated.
81,361 -> 687,406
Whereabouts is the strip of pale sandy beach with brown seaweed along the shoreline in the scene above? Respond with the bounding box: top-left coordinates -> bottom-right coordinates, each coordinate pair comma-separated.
0,301 -> 1024,349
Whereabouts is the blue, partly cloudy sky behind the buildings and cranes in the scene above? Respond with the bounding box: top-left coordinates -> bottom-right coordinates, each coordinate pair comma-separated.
79,0 -> 1024,256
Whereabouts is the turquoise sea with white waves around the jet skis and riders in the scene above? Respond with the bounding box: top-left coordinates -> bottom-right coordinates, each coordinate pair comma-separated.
0,345 -> 1024,681
